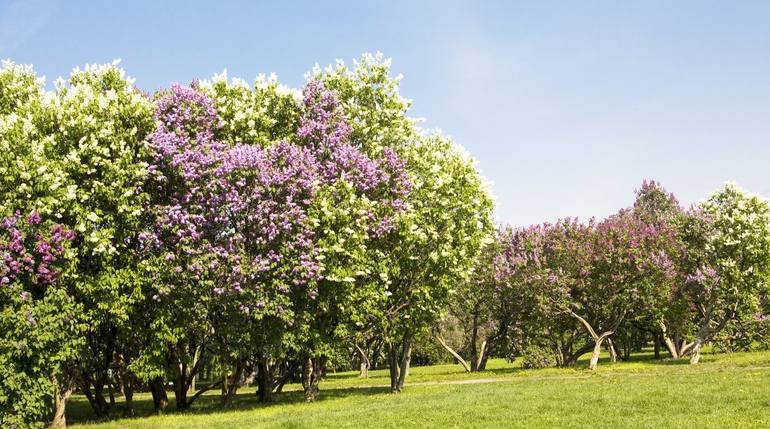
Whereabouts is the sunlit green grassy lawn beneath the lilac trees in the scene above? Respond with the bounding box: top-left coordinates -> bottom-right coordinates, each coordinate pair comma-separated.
68,352 -> 770,429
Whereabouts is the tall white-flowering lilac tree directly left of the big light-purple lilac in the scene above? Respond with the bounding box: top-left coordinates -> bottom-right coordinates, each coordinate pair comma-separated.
49,64 -> 153,415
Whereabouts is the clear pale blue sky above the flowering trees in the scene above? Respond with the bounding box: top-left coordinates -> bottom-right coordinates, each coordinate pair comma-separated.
0,0 -> 770,225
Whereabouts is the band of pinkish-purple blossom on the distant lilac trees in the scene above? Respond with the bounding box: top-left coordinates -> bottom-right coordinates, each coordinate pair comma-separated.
493,210 -> 682,306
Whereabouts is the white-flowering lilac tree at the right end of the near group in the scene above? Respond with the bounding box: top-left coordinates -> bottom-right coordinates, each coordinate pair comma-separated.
311,54 -> 492,392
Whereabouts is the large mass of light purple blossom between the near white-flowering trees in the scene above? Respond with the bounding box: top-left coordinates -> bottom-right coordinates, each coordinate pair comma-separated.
139,78 -> 411,314
